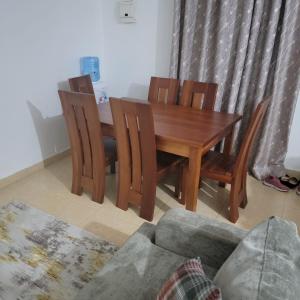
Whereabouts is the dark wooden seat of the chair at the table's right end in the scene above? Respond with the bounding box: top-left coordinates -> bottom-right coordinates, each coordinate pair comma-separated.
201,151 -> 235,183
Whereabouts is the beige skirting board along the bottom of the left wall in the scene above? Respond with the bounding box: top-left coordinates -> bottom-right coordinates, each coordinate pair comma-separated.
0,149 -> 71,189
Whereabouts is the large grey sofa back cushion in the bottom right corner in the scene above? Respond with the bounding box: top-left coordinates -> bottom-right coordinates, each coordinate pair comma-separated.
214,217 -> 300,300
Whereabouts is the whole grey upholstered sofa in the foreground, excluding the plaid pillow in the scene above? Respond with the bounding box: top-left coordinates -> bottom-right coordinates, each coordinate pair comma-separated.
77,209 -> 300,300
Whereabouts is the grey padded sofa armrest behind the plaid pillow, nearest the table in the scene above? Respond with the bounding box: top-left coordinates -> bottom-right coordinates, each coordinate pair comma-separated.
155,208 -> 247,269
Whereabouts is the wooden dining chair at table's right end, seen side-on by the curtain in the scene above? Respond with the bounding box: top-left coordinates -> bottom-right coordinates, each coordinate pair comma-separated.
201,99 -> 270,223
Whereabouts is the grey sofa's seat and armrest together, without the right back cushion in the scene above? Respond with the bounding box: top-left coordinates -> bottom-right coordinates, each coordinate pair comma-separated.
77,209 -> 247,300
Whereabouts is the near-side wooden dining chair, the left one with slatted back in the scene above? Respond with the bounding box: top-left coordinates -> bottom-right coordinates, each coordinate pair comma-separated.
58,90 -> 116,203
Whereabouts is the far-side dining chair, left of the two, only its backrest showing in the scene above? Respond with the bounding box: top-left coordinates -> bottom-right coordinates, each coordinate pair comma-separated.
148,77 -> 179,104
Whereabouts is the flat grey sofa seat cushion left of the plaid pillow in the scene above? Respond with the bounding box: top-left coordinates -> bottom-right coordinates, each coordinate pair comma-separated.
76,223 -> 187,300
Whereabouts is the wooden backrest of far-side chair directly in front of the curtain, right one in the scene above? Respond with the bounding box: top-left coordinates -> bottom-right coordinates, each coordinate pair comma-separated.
179,80 -> 218,110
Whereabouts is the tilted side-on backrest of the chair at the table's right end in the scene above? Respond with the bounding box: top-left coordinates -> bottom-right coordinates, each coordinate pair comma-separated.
233,99 -> 270,182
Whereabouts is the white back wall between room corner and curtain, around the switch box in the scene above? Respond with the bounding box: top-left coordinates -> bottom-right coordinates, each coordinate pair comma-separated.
102,0 -> 174,99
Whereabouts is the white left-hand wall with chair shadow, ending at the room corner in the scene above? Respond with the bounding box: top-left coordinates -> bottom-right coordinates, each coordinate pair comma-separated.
0,0 -> 103,178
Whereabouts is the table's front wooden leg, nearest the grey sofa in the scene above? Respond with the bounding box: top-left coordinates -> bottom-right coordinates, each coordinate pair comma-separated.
184,148 -> 202,211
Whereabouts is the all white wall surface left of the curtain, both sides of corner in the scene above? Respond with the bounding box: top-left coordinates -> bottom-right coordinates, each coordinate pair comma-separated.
0,0 -> 174,178
